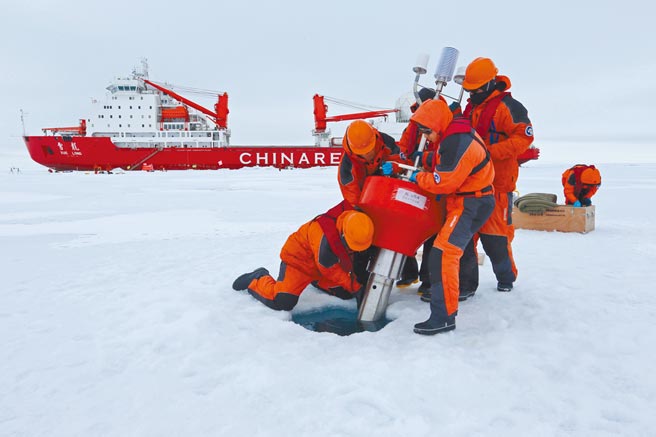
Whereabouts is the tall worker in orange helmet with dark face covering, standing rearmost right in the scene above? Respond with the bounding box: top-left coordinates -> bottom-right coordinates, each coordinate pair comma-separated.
462,58 -> 533,295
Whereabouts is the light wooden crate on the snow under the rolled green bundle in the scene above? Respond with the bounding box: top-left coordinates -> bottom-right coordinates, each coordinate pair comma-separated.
512,205 -> 595,234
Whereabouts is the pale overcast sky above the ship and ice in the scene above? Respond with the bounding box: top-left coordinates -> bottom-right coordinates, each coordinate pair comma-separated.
0,0 -> 656,149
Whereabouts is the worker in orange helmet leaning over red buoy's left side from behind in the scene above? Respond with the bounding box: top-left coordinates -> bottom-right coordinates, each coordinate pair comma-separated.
337,120 -> 399,282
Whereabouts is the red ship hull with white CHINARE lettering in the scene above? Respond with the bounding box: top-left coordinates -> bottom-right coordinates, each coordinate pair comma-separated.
24,136 -> 343,171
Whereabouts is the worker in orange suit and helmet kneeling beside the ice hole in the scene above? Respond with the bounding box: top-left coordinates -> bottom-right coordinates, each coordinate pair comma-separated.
232,202 -> 374,311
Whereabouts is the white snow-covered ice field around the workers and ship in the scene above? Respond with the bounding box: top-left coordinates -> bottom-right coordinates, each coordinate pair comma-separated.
0,143 -> 656,437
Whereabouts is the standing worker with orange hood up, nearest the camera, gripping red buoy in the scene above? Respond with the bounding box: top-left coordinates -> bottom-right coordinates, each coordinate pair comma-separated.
410,100 -> 495,335
